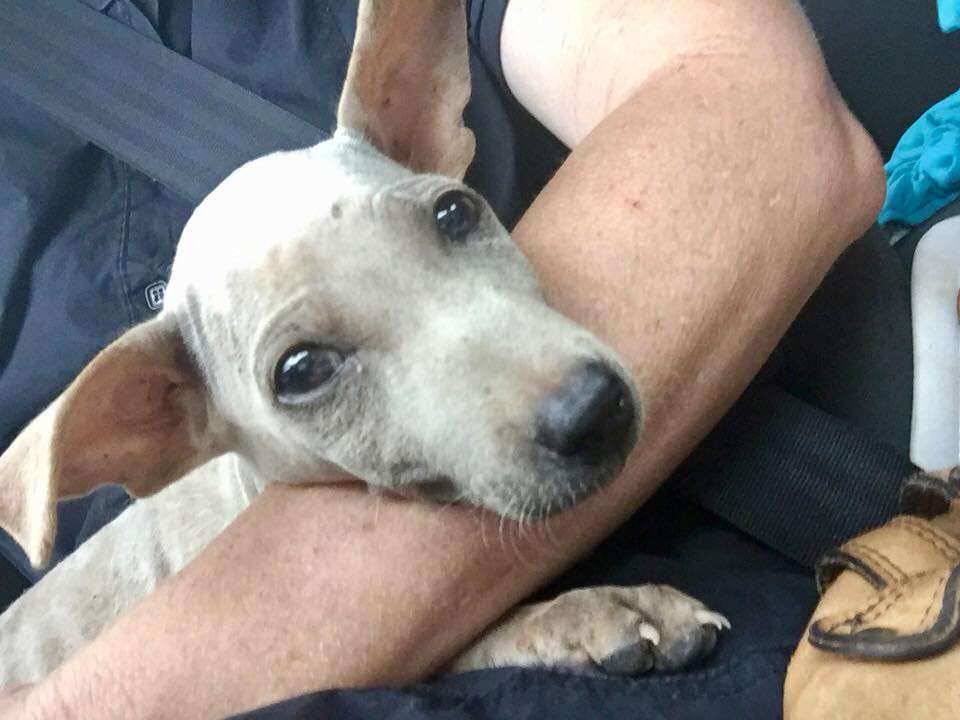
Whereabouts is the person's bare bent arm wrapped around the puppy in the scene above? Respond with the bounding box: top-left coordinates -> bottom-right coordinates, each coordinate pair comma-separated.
16,0 -> 882,720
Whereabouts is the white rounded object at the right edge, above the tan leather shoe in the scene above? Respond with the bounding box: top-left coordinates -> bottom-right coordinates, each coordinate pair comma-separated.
910,217 -> 960,470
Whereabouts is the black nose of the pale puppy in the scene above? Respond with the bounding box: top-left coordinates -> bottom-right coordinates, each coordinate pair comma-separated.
536,362 -> 636,464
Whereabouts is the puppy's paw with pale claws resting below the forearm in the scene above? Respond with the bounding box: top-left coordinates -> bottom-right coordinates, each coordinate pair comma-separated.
452,585 -> 730,676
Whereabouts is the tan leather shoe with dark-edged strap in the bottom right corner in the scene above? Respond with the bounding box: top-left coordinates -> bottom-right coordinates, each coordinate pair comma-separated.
784,468 -> 960,720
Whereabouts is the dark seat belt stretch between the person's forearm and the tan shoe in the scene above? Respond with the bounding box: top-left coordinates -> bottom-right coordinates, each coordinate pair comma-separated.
676,382 -> 917,568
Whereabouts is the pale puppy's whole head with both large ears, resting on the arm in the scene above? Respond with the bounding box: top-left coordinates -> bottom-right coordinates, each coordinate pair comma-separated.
0,0 -> 640,563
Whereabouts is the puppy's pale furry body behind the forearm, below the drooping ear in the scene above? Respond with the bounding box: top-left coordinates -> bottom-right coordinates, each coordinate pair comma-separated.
0,457 -> 253,690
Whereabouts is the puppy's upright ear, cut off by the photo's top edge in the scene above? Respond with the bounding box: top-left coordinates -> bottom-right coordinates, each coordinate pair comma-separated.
338,0 -> 475,179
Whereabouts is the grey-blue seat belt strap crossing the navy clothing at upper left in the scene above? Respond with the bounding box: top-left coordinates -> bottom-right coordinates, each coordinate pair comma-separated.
0,0 -> 324,204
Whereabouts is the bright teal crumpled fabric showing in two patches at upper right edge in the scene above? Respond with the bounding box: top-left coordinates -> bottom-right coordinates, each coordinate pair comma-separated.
878,0 -> 960,225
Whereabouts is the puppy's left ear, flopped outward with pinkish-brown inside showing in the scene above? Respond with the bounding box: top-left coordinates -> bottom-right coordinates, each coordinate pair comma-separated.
0,316 -> 217,567
